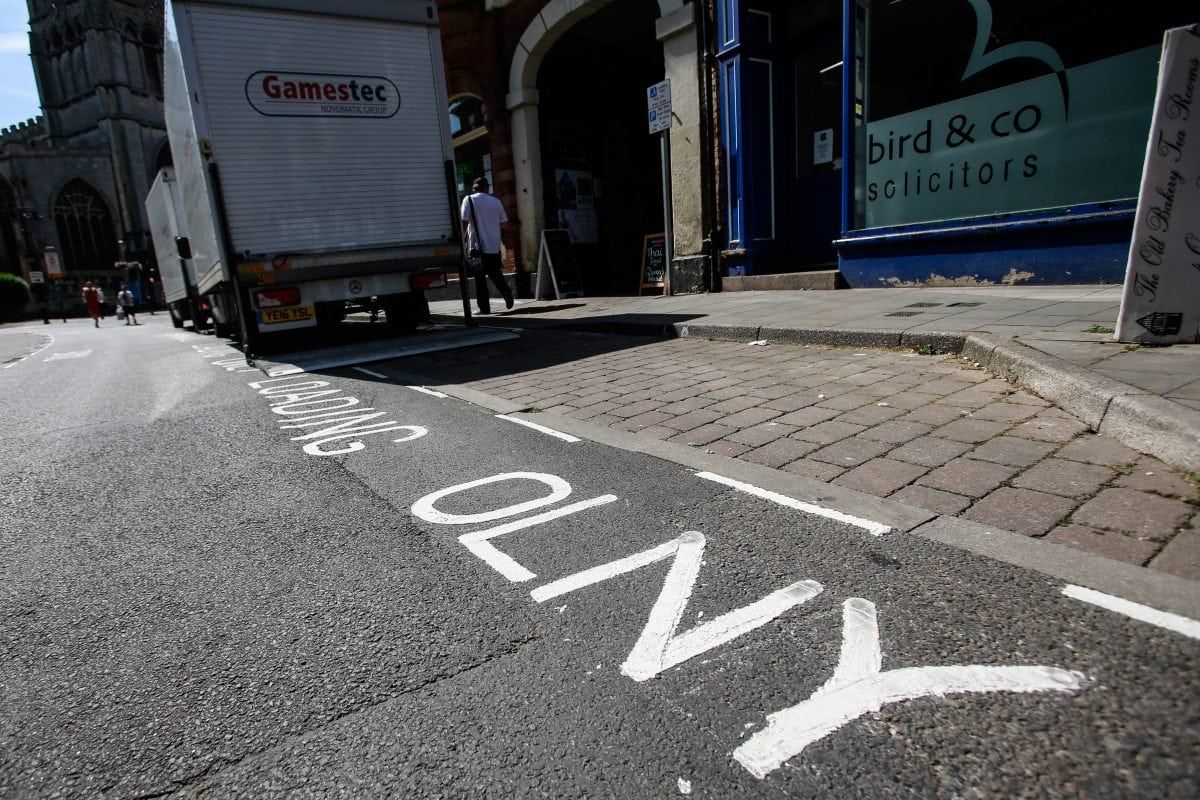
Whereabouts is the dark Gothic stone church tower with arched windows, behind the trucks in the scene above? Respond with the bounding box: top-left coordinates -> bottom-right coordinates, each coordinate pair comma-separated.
0,0 -> 170,285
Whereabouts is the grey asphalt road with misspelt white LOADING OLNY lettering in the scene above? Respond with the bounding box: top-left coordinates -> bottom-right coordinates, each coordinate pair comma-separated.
0,317 -> 1200,798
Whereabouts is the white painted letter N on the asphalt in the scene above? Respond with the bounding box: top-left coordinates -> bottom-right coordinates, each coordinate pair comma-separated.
530,530 -> 823,681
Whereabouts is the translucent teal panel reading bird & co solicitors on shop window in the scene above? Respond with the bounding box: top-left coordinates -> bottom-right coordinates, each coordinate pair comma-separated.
863,46 -> 1159,228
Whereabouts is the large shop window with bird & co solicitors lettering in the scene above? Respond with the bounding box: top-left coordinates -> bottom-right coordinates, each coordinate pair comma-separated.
854,0 -> 1194,228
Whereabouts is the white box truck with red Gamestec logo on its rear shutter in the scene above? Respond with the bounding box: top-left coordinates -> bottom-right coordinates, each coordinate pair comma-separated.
164,0 -> 462,353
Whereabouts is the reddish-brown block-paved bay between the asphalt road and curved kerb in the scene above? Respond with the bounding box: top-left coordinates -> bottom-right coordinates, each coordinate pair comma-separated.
406,331 -> 1200,579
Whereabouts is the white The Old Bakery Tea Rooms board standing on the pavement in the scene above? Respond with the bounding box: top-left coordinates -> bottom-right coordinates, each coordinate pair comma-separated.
1116,25 -> 1200,344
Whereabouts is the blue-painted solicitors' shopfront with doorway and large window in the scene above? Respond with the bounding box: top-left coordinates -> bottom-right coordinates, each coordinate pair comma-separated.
712,0 -> 1195,287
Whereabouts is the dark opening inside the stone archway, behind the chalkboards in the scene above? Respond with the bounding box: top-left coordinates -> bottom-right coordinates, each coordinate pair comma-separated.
538,0 -> 664,295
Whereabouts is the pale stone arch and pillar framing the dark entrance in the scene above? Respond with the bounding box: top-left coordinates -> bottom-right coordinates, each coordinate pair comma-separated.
505,0 -> 700,281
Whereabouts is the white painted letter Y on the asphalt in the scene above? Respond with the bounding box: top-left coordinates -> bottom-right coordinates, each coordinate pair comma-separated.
733,597 -> 1086,778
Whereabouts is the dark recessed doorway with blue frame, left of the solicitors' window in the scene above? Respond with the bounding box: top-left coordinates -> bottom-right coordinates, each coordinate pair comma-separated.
722,0 -> 842,273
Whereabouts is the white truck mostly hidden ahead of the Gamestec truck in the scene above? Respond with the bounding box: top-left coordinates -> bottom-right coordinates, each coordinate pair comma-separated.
146,167 -> 206,330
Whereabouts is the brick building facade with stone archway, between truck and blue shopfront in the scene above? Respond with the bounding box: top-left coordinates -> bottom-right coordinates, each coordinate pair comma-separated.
438,0 -> 712,294
